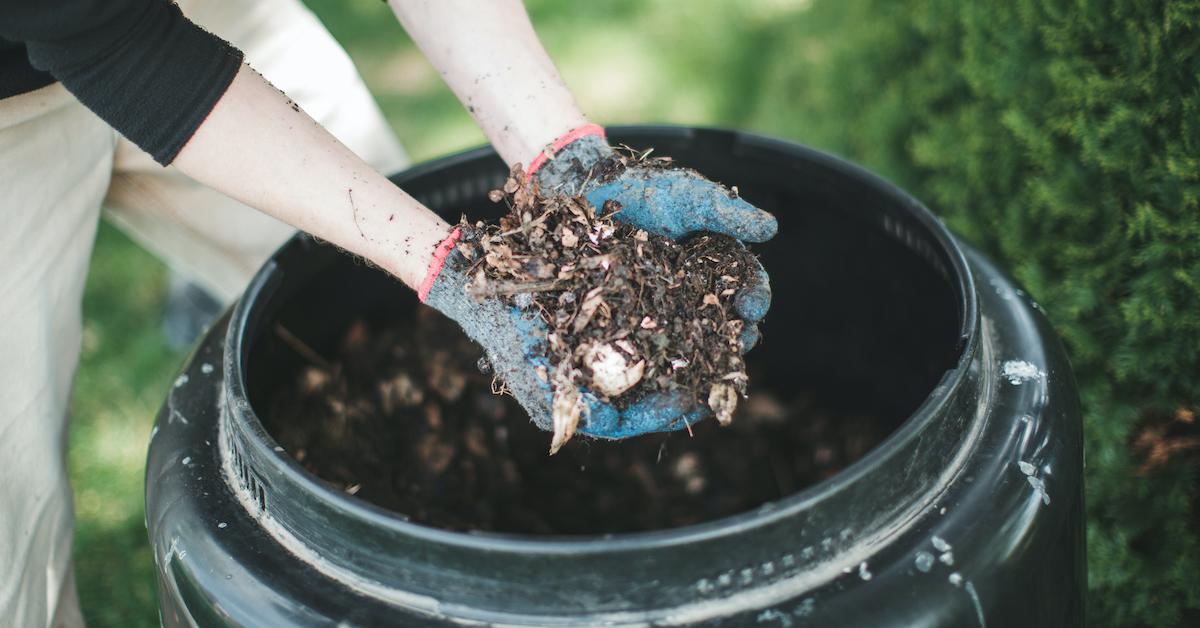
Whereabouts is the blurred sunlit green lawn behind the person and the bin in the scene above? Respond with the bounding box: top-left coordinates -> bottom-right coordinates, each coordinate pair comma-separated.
70,0 -> 817,628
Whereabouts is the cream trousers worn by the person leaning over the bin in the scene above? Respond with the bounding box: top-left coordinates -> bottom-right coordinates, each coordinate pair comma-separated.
0,0 -> 407,627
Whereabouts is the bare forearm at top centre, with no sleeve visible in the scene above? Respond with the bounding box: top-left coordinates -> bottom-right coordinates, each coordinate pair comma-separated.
389,0 -> 587,165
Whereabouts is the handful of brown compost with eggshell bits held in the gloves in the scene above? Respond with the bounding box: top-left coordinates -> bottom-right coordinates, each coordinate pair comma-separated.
458,165 -> 756,453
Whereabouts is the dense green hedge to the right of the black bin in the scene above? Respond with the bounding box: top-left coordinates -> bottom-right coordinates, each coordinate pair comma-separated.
748,0 -> 1200,626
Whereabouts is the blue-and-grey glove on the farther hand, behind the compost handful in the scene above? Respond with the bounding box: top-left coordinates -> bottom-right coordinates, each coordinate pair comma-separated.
530,125 -> 778,357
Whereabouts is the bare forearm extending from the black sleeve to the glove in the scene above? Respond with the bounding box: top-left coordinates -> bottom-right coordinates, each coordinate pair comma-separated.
174,66 -> 450,289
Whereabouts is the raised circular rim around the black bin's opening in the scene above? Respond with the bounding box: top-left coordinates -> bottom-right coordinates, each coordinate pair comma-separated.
223,126 -> 979,555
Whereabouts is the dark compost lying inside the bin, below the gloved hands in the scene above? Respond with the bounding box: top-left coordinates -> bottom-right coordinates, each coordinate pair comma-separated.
266,306 -> 886,534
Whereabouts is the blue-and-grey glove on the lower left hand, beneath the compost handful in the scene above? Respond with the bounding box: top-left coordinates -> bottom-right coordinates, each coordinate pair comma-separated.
418,229 -> 707,454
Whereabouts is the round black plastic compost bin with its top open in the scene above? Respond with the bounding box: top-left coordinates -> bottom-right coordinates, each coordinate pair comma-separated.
146,127 -> 1085,627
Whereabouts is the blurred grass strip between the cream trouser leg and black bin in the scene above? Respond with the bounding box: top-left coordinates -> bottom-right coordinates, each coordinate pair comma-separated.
70,225 -> 182,627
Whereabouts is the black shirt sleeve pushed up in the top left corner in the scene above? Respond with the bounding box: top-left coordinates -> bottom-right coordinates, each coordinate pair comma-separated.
0,0 -> 241,165
